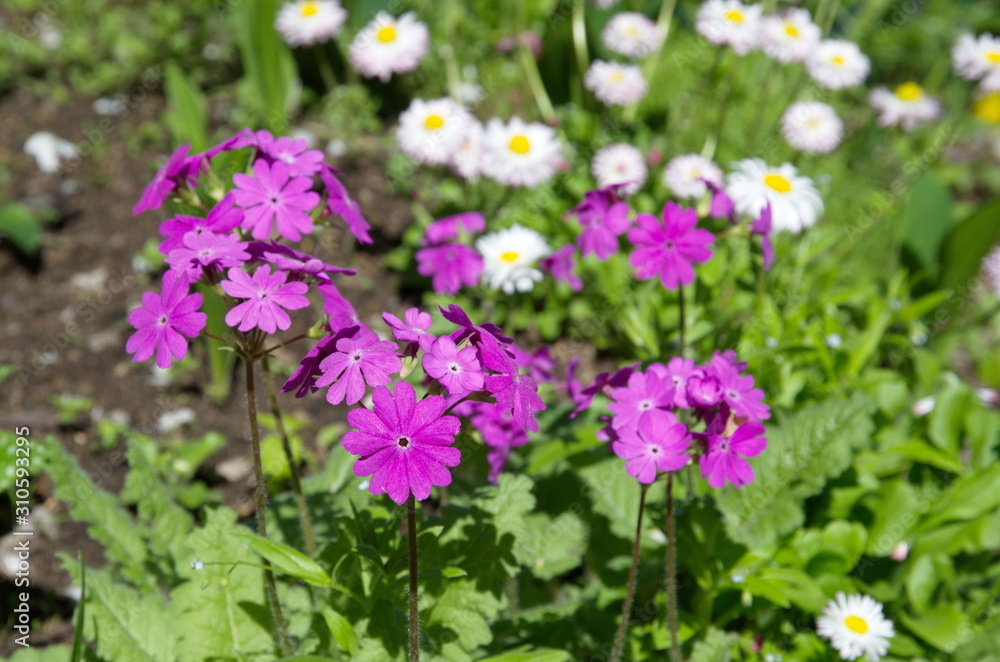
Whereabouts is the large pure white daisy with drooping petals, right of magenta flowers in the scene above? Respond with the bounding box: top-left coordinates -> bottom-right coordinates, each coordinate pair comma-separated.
726,159 -> 823,234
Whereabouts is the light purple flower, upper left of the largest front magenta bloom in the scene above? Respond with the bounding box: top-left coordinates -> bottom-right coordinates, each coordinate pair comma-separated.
316,328 -> 403,405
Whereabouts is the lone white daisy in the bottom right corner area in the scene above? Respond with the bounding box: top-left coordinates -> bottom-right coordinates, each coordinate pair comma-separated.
816,591 -> 895,662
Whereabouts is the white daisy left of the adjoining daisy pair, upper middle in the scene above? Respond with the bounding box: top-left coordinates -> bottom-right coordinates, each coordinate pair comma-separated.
396,97 -> 472,165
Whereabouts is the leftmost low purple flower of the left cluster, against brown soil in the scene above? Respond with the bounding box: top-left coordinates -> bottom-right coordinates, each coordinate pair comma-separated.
125,271 -> 208,368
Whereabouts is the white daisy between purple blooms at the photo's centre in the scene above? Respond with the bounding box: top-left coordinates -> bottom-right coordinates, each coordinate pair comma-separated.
476,225 -> 550,294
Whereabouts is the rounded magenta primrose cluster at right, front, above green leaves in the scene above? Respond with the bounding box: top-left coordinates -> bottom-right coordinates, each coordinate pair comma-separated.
567,350 -> 771,488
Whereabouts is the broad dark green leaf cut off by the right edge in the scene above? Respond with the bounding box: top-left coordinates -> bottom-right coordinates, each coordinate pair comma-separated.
941,198 -> 1000,291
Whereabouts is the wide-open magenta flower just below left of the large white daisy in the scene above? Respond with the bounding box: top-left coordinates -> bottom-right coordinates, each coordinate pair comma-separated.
628,202 -> 715,290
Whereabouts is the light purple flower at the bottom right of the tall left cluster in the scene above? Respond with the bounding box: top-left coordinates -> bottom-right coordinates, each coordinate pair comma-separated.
221,264 -> 309,333
